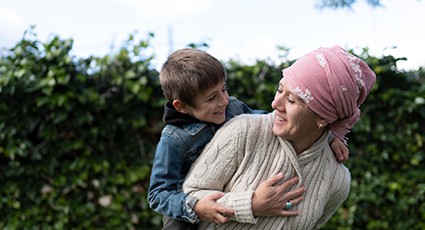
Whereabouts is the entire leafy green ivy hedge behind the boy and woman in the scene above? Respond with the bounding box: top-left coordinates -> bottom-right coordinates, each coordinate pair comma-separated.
0,30 -> 425,229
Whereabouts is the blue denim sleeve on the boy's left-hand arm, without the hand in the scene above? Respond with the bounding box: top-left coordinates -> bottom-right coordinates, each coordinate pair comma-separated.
148,128 -> 199,223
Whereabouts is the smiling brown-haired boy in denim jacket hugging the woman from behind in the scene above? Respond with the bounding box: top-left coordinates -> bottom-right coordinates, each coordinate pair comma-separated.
148,48 -> 344,229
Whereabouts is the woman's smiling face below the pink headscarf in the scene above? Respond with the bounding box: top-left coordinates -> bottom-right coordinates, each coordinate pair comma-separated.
272,78 -> 327,142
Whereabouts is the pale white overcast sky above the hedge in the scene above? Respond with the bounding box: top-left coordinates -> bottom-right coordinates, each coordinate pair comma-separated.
0,0 -> 425,70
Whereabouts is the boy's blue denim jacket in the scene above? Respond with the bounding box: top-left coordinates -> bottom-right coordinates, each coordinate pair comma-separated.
148,97 -> 268,223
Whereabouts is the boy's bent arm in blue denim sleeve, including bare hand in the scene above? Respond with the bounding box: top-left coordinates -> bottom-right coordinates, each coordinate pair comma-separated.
148,134 -> 234,224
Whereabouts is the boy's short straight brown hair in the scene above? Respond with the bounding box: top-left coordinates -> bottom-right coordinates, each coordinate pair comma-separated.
159,48 -> 227,107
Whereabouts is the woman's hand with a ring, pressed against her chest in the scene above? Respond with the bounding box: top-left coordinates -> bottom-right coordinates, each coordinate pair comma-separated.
252,173 -> 306,217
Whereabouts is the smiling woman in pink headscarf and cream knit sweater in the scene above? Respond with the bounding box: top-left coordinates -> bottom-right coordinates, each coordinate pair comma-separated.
183,46 -> 376,229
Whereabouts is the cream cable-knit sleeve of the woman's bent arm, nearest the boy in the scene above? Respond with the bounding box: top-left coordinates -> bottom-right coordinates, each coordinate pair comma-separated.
183,118 -> 257,224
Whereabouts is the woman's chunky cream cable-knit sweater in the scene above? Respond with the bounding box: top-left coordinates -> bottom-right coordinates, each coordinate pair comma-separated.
183,113 -> 351,230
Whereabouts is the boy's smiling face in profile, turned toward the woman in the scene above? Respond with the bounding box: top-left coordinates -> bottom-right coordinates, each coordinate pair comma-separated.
188,82 -> 229,125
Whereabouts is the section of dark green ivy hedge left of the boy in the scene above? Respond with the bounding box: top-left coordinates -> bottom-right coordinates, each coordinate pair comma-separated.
0,31 -> 164,229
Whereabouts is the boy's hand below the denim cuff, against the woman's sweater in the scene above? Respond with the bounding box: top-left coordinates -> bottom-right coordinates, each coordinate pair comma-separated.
193,193 -> 235,224
